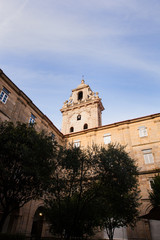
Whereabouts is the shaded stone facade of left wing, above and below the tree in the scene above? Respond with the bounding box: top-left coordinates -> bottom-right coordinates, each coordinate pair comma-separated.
0,70 -> 64,236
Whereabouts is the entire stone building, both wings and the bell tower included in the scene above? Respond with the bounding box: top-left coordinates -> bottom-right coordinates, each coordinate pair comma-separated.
0,68 -> 160,239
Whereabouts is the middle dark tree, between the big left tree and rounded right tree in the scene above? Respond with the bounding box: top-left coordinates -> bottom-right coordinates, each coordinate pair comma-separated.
43,143 -> 98,239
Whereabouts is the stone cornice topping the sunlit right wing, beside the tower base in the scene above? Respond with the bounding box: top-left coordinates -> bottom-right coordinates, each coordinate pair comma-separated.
64,113 -> 160,137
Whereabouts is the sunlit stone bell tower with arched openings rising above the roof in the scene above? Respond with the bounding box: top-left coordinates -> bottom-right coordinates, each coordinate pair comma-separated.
61,79 -> 104,134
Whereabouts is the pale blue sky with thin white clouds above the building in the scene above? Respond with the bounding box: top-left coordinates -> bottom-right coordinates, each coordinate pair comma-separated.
0,0 -> 160,129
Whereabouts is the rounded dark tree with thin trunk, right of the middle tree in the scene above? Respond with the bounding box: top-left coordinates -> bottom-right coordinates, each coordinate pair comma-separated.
96,144 -> 139,240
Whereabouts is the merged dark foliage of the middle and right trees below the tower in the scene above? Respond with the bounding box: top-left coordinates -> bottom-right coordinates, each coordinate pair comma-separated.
46,145 -> 139,239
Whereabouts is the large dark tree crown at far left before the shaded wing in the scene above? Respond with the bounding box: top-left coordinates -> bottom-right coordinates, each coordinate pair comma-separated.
0,122 -> 56,231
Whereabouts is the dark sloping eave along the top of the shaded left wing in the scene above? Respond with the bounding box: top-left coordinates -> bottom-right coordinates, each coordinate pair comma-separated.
0,69 -> 64,138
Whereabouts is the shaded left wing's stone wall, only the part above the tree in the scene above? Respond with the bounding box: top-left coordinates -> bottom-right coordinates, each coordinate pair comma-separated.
0,70 -> 64,145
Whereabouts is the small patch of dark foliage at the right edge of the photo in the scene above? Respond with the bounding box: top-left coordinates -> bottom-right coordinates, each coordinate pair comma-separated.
149,175 -> 160,207
